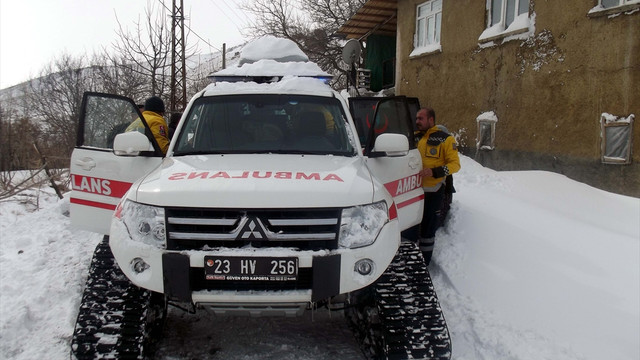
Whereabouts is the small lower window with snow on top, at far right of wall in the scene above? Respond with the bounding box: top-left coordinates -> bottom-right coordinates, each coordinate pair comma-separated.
600,113 -> 635,164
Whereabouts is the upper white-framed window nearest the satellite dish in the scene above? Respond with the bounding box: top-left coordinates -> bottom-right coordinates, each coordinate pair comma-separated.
410,0 -> 443,56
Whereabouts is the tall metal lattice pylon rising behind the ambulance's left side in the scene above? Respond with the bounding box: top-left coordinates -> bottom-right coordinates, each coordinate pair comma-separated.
170,0 -> 187,113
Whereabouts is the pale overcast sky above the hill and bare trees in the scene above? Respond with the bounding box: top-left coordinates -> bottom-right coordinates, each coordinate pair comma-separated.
0,0 -> 250,89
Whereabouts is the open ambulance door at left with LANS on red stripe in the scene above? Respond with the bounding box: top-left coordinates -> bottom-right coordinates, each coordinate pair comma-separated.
70,93 -> 162,234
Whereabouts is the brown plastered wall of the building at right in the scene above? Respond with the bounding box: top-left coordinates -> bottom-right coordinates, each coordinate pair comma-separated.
396,0 -> 640,197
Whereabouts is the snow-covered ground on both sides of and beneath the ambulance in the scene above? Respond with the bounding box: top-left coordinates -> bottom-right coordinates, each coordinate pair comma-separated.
0,156 -> 640,360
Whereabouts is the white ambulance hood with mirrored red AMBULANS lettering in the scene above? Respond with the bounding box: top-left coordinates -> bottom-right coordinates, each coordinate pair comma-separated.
131,154 -> 374,209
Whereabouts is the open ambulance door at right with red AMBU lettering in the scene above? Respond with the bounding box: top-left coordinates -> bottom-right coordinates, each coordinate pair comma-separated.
349,96 -> 424,230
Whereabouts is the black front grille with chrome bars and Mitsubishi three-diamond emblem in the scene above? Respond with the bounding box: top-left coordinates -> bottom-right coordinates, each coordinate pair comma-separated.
165,208 -> 341,250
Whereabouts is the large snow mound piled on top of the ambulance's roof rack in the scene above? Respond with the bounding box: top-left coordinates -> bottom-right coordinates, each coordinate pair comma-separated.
210,36 -> 332,82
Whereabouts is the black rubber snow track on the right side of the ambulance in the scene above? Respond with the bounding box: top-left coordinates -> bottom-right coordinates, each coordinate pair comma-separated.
346,241 -> 451,360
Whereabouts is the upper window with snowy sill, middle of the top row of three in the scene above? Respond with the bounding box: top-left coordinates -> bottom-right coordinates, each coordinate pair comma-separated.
478,0 -> 530,41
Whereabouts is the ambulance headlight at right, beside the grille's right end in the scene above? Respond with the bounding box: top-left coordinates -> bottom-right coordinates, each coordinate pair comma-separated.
338,201 -> 389,249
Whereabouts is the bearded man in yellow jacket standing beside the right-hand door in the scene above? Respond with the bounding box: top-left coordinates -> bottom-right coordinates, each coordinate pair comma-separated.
416,108 -> 460,265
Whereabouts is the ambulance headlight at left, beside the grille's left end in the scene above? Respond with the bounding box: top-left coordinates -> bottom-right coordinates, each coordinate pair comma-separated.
114,200 -> 166,249
